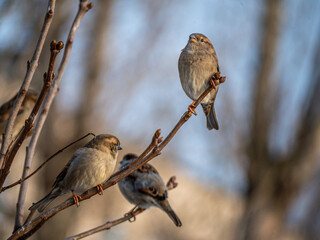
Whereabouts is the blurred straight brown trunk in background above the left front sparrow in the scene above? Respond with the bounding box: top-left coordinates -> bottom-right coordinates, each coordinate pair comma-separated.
75,1 -> 113,137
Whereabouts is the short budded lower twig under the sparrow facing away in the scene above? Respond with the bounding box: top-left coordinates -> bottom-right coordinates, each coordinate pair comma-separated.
65,176 -> 178,240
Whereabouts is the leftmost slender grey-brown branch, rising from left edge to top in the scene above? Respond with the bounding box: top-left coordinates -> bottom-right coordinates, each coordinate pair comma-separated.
0,0 -> 56,169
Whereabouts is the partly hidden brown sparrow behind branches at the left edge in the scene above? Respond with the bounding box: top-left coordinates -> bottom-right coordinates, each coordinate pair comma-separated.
0,90 -> 38,142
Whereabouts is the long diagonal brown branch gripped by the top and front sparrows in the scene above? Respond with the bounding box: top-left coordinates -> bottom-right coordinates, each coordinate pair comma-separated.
9,74 -> 225,239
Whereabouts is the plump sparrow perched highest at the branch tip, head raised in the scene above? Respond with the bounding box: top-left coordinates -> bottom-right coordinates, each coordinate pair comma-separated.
178,33 -> 220,130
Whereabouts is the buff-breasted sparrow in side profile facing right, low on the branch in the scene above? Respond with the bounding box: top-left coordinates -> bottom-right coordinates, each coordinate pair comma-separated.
29,134 -> 122,212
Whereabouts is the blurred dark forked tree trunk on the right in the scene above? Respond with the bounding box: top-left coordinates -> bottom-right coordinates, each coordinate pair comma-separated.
239,0 -> 320,240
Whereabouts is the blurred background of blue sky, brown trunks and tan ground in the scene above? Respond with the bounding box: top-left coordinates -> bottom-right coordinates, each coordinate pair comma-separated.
0,0 -> 320,240
